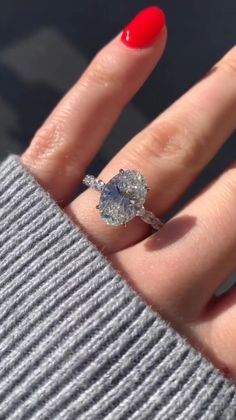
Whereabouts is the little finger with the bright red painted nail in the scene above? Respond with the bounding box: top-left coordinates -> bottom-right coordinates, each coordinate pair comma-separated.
22,7 -> 166,204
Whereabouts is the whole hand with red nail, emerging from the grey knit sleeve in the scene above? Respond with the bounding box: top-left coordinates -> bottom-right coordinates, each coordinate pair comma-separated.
22,7 -> 236,380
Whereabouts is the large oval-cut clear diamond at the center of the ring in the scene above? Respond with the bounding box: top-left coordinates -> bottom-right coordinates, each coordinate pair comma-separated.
99,170 -> 147,226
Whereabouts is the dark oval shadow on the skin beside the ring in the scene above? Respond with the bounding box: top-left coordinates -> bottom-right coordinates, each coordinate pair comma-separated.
145,215 -> 196,251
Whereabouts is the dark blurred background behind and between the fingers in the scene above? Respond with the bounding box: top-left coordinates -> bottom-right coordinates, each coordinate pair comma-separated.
0,0 -> 236,286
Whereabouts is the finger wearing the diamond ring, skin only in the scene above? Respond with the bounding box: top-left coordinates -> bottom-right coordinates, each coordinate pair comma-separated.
70,48 -> 236,252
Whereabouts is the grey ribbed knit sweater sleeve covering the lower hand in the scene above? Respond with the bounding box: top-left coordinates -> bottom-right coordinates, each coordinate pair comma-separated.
0,155 -> 236,420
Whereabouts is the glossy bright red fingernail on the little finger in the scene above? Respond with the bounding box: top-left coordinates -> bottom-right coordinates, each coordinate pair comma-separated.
121,6 -> 165,48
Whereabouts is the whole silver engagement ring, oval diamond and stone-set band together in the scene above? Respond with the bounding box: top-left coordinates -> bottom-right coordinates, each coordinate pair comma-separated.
82,169 -> 163,230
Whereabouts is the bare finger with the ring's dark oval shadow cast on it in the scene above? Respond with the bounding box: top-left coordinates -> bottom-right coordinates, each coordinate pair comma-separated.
110,164 -> 236,322
